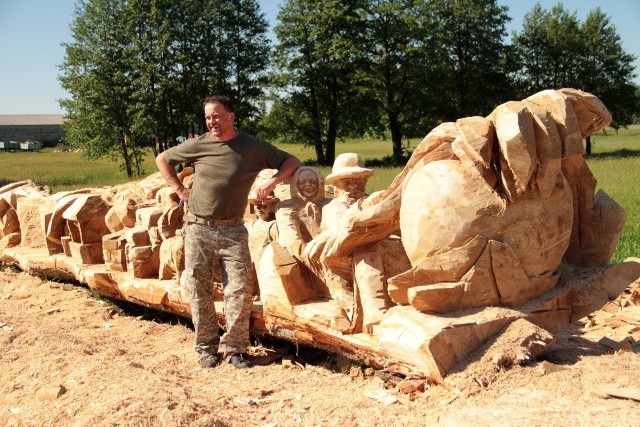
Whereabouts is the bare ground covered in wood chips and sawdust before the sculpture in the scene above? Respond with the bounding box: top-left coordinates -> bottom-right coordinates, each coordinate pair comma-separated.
0,268 -> 640,426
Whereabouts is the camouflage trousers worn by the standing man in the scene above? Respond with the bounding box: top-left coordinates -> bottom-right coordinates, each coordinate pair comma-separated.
184,223 -> 253,357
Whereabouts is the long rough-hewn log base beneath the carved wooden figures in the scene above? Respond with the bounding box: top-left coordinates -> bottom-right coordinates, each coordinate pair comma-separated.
1,247 -> 640,382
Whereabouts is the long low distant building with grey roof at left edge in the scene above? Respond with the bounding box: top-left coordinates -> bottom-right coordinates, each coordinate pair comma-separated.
0,114 -> 64,147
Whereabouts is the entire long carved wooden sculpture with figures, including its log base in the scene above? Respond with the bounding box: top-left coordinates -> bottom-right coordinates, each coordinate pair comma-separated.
0,89 -> 640,380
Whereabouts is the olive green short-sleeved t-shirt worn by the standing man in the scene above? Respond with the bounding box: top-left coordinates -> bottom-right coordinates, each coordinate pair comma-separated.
164,132 -> 291,219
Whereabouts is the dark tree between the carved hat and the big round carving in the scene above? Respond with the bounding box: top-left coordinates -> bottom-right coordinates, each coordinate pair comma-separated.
354,0 -> 438,160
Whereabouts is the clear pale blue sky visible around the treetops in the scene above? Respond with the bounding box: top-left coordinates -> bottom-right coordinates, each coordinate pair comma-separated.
0,0 -> 640,114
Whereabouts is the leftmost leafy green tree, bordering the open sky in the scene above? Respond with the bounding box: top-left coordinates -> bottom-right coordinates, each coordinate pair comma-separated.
60,0 -> 141,177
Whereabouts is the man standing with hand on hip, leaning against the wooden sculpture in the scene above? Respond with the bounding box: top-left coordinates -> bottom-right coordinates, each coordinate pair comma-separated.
156,96 -> 300,368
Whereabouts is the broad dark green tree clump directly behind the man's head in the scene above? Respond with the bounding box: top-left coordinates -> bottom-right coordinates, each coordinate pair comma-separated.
126,0 -> 270,149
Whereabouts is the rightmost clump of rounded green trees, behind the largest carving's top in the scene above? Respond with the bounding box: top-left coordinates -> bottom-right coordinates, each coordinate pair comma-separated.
513,4 -> 638,154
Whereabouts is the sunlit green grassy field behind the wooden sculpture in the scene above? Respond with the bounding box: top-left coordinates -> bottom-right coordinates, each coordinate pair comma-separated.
0,125 -> 640,262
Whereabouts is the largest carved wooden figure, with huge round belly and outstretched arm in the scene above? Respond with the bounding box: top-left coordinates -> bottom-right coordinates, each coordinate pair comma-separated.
307,89 -> 624,312
